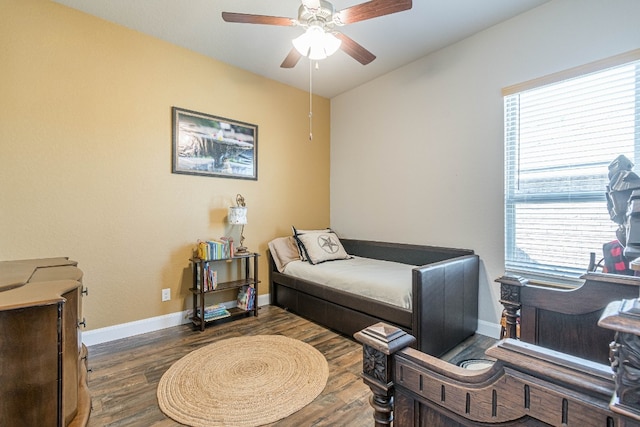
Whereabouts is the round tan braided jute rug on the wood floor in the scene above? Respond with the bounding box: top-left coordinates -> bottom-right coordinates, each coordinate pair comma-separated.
157,335 -> 329,427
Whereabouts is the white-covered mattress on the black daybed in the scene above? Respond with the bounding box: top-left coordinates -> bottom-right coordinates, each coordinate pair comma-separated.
284,257 -> 416,310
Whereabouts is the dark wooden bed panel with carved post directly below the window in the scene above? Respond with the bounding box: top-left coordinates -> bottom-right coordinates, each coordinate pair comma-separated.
496,273 -> 640,363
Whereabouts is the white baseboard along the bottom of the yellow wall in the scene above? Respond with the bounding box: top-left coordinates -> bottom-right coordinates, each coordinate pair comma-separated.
82,294 -> 269,347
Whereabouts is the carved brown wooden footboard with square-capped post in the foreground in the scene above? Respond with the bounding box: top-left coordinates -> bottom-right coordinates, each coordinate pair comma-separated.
355,300 -> 640,427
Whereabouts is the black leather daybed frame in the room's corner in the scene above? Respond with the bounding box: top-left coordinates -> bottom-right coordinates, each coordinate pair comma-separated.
269,235 -> 479,356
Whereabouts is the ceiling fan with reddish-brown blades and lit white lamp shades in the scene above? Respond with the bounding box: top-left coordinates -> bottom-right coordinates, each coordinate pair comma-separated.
222,0 -> 412,68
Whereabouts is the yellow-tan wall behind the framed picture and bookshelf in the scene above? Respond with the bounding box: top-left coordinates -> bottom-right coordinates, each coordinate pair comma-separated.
0,0 -> 330,330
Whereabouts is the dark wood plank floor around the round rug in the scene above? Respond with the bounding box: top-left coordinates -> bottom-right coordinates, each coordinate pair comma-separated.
89,306 -> 494,427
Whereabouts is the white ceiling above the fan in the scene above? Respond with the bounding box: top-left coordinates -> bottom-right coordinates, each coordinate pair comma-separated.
54,0 -> 549,98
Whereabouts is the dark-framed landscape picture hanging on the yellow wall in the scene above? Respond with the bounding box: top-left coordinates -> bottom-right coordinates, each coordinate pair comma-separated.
171,107 -> 258,180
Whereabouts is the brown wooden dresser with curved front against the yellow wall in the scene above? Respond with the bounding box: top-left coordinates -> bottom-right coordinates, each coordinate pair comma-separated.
0,258 -> 91,427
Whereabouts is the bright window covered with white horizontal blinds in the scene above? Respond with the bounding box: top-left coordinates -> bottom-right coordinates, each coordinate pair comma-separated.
503,50 -> 640,281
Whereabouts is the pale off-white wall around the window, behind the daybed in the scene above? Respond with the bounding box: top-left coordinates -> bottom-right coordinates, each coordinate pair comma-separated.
331,0 -> 640,334
